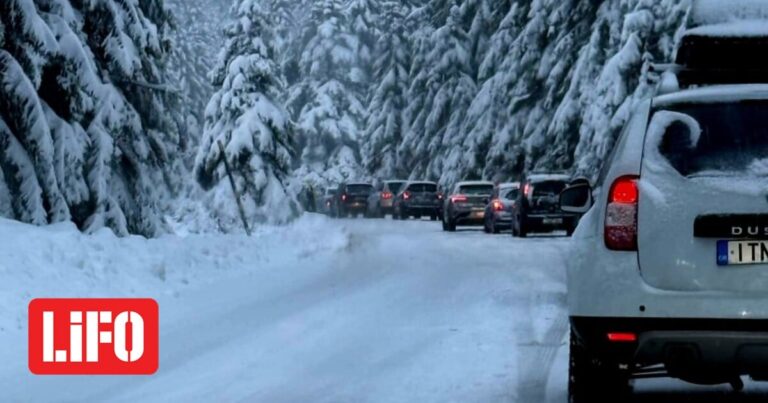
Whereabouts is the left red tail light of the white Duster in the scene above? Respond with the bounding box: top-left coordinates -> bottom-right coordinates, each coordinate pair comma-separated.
605,176 -> 640,251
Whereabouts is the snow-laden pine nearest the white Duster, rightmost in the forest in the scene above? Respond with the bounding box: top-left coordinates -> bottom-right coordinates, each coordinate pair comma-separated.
568,0 -> 690,177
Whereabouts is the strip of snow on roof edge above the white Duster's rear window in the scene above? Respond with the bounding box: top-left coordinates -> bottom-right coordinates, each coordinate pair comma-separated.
653,84 -> 768,108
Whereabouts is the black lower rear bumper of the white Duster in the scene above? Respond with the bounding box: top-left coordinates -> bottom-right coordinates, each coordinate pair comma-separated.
571,317 -> 768,383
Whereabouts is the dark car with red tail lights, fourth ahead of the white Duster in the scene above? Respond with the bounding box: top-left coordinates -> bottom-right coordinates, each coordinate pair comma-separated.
392,181 -> 443,221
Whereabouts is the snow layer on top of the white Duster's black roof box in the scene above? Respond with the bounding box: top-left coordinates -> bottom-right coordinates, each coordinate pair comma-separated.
689,0 -> 768,27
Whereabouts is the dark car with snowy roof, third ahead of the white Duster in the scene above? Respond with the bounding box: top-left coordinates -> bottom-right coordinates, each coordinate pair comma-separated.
443,181 -> 495,231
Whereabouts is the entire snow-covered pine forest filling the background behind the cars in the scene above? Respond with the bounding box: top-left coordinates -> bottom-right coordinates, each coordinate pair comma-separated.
0,0 -> 689,236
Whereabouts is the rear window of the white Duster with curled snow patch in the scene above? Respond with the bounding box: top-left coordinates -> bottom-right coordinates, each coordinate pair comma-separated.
651,101 -> 768,177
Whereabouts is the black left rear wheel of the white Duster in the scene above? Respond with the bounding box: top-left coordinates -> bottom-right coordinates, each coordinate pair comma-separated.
568,331 -> 630,403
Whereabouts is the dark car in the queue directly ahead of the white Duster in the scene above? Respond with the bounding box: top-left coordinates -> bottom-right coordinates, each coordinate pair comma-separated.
512,174 -> 578,237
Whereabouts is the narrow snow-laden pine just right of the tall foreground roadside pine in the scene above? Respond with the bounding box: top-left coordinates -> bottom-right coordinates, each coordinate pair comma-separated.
288,0 -> 365,186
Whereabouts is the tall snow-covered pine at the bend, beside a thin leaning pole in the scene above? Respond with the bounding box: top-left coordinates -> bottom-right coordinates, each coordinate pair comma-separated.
195,0 -> 299,230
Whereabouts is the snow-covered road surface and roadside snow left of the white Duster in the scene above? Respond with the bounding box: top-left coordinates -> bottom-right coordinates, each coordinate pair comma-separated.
0,218 -> 765,403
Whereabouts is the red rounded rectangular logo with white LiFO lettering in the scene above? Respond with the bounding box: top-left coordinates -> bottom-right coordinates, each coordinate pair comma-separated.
29,299 -> 159,375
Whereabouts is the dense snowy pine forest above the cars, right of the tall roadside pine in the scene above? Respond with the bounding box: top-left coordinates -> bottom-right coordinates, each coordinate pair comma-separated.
244,0 -> 689,190
